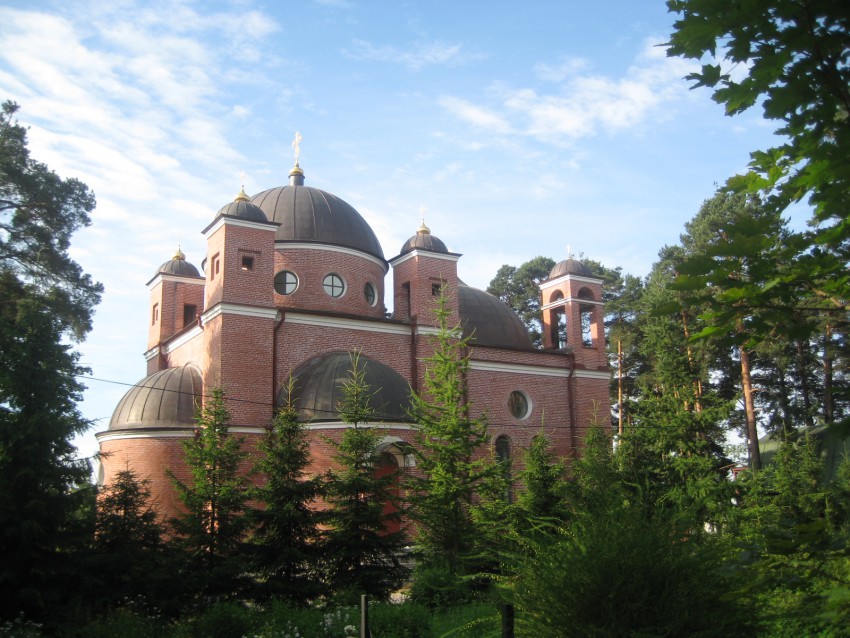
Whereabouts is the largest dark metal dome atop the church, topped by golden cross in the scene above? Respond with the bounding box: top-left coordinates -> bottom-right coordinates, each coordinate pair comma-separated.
251,169 -> 385,261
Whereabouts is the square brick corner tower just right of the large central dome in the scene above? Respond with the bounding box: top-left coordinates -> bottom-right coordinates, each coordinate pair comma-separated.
390,219 -> 460,325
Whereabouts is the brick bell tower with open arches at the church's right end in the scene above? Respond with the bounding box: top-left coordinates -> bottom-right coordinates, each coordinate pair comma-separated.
540,256 -> 608,369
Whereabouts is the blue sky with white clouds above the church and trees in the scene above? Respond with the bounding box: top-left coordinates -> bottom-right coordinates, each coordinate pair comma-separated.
0,0 -> 788,462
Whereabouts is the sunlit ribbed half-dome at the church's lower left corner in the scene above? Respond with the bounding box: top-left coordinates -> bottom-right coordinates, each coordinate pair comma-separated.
109,366 -> 203,430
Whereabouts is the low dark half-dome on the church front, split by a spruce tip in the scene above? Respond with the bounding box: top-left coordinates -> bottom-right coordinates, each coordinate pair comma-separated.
286,352 -> 411,423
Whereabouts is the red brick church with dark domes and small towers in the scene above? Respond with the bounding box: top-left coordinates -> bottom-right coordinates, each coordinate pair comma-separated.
97,155 -> 609,516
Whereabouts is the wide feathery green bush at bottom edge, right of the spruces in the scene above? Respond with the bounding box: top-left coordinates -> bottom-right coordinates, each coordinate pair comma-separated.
514,428 -> 748,636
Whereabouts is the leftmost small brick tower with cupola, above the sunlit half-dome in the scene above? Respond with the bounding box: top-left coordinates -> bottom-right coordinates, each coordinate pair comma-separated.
147,247 -> 204,374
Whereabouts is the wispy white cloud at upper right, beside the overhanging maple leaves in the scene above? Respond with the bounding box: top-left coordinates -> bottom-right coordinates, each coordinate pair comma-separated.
438,42 -> 689,144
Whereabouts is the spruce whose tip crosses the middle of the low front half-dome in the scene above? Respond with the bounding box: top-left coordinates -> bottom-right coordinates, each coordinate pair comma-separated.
323,352 -> 405,599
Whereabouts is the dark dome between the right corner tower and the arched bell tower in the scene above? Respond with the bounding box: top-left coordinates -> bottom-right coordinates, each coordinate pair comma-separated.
457,281 -> 534,350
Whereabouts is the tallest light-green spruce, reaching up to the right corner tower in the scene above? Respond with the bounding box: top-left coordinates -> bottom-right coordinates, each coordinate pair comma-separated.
408,295 -> 504,574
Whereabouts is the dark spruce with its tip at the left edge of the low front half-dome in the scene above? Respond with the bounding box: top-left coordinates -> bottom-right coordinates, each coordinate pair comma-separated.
252,380 -> 322,603
